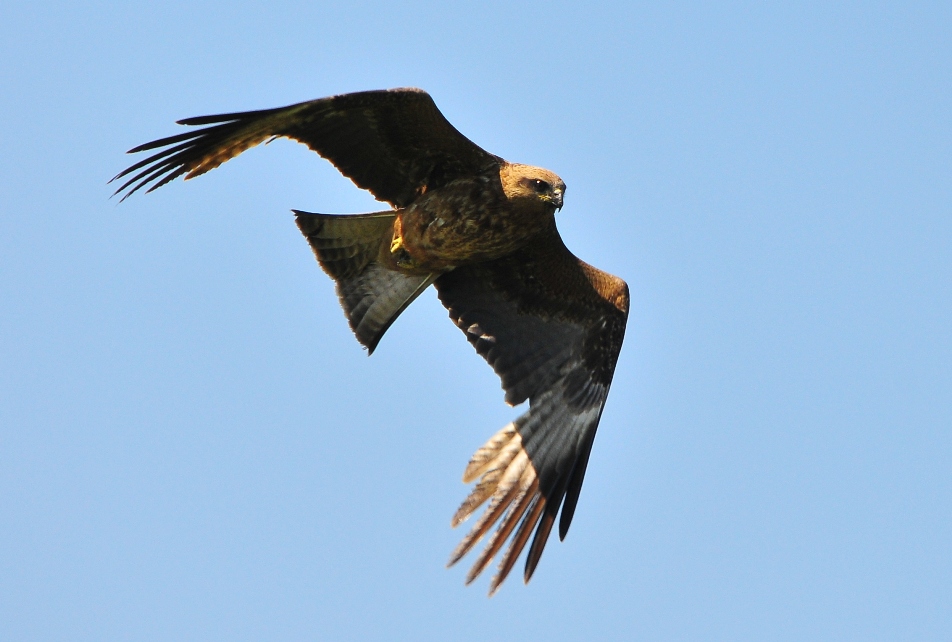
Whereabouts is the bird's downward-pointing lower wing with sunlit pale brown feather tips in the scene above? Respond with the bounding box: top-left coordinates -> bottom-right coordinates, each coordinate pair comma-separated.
436,226 -> 628,594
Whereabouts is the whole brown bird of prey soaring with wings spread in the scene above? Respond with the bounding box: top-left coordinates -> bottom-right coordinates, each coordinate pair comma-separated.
113,89 -> 628,595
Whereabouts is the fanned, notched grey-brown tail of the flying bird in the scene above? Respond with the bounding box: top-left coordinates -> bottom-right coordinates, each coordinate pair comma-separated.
293,210 -> 439,354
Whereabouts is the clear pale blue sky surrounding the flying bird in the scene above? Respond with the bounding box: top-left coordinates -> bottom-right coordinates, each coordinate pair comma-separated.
0,1 -> 952,641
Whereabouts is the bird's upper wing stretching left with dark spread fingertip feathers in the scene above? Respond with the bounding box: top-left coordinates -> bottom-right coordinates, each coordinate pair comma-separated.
112,89 -> 501,207
